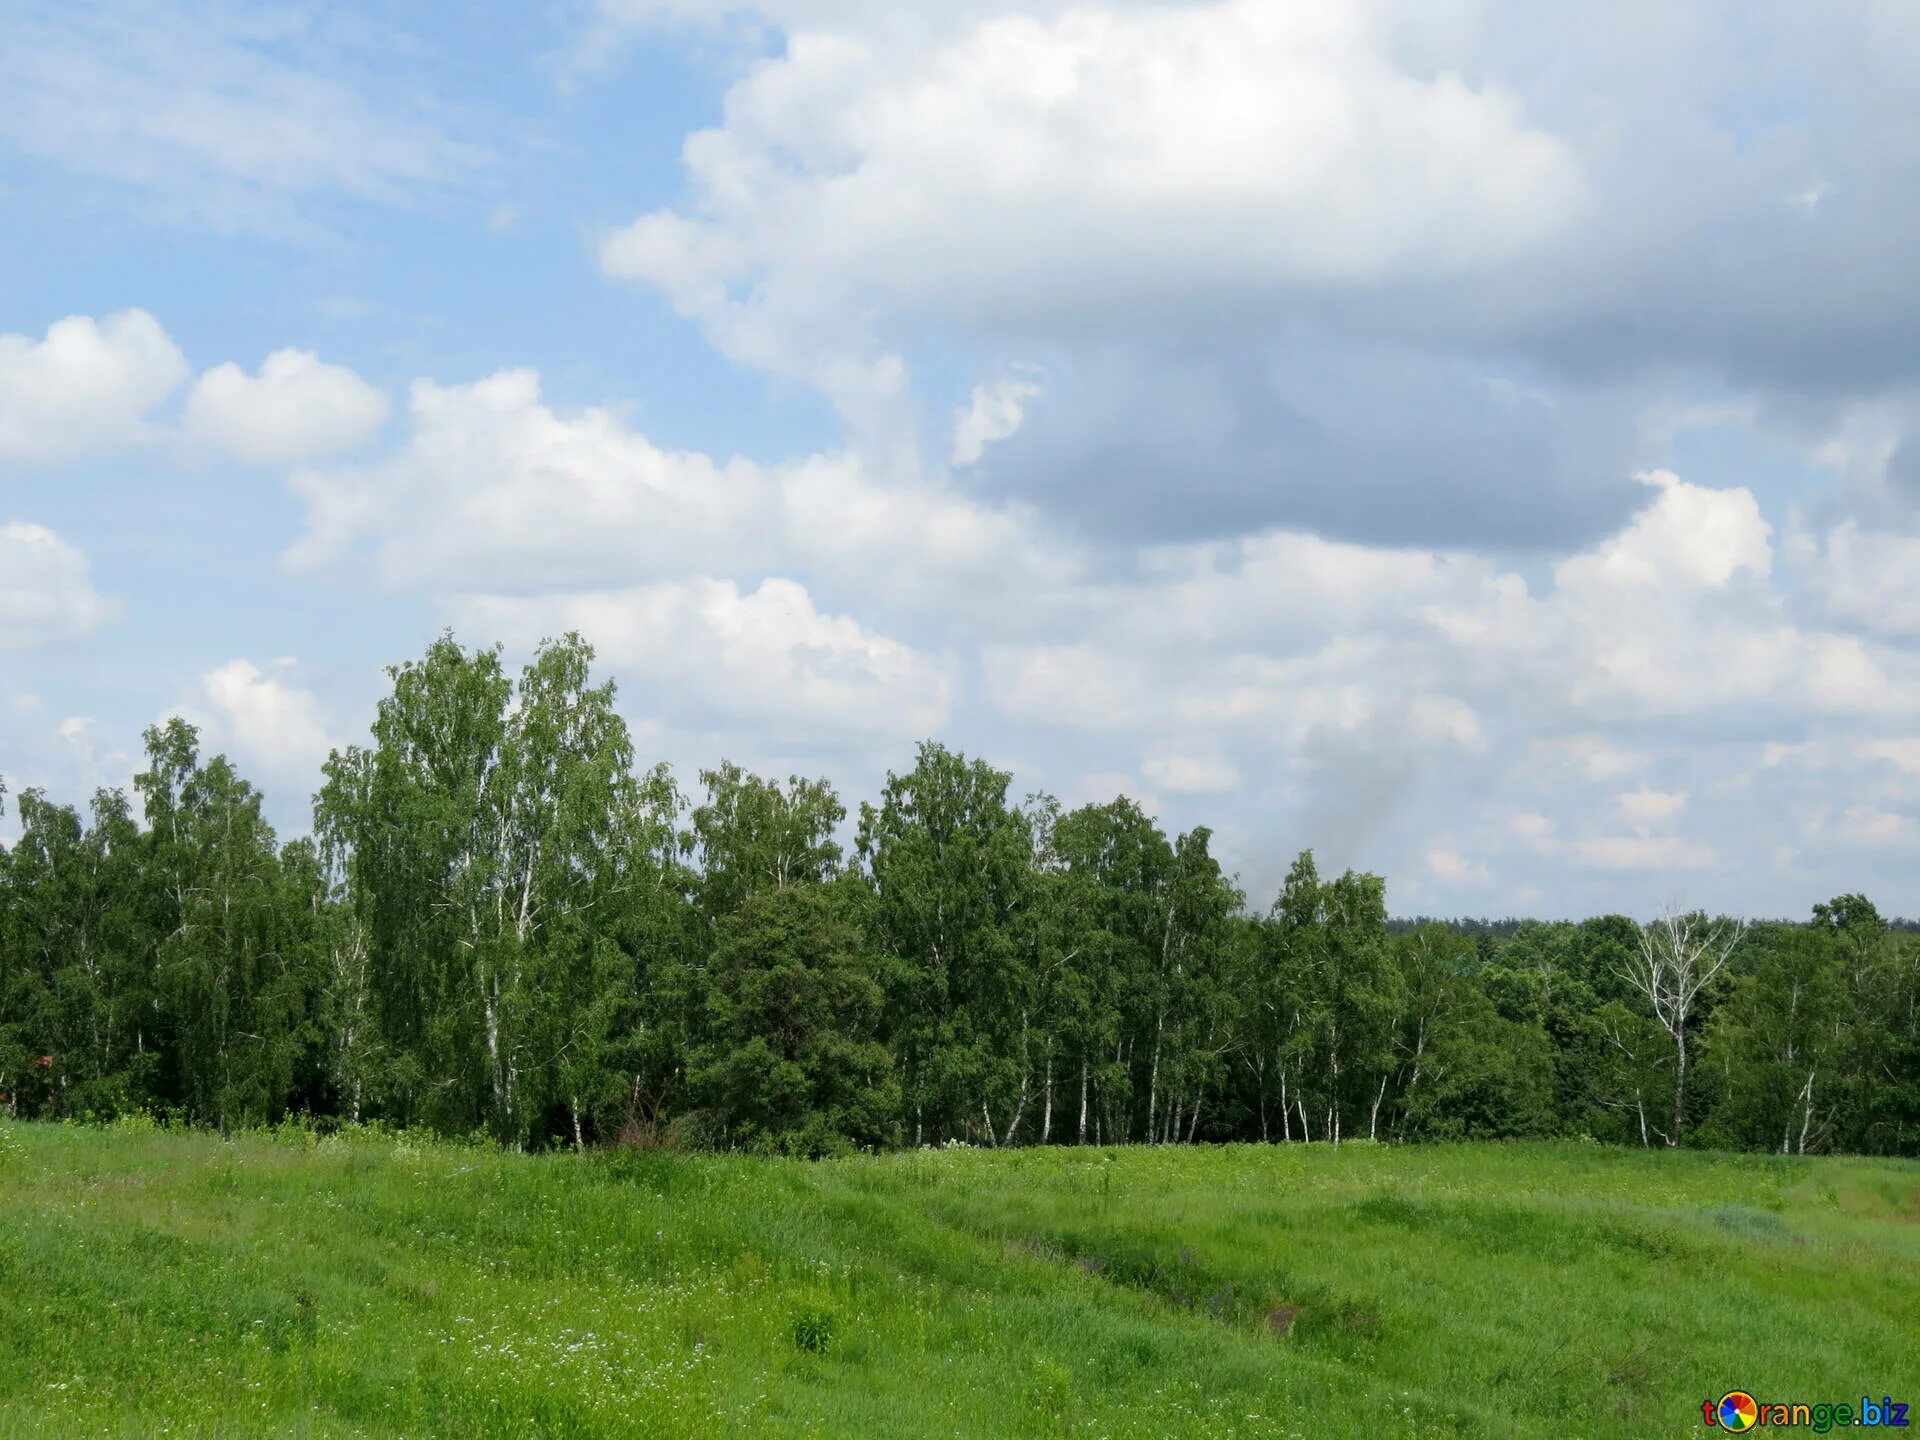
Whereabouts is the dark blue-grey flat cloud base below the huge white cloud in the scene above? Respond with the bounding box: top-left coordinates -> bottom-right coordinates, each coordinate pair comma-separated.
977,340 -> 1645,549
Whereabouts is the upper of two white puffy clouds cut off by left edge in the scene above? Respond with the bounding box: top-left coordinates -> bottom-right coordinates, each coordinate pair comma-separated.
0,309 -> 188,463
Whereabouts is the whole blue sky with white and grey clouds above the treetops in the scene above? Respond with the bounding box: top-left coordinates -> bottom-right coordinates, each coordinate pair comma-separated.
0,0 -> 1920,918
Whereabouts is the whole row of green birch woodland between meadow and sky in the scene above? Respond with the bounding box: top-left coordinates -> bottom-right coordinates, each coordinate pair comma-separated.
0,636 -> 1920,1154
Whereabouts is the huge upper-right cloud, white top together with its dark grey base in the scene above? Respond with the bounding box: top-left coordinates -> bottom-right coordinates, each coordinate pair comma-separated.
576,0 -> 1920,564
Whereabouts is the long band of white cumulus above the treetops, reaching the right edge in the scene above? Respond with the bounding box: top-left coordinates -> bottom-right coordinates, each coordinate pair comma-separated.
274,341 -> 1920,913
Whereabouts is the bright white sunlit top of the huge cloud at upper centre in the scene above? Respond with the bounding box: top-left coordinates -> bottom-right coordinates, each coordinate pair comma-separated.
601,0 -> 1584,403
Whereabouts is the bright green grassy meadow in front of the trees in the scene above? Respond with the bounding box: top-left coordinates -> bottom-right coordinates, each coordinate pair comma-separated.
0,1121 -> 1920,1440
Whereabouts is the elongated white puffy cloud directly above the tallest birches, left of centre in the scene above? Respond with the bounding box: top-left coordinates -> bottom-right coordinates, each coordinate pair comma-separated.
286,371 -> 1075,612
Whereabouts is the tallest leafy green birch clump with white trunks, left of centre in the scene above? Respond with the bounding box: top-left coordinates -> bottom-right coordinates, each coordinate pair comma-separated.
317,636 -> 636,1144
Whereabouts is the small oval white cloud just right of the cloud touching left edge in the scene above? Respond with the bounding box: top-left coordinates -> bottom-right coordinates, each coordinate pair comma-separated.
186,349 -> 388,465
